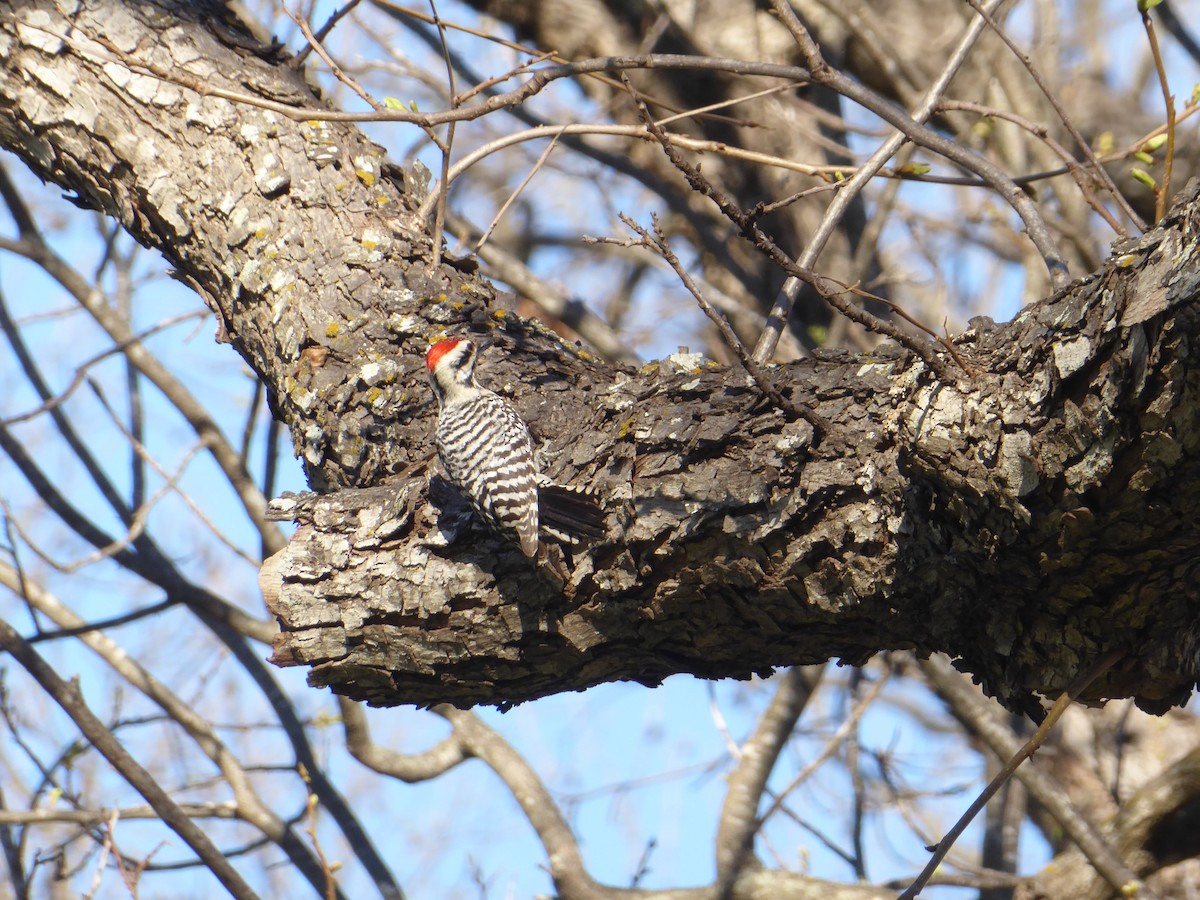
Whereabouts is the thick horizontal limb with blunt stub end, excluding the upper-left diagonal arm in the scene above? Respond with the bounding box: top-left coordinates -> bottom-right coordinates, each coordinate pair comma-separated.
264,193 -> 1200,716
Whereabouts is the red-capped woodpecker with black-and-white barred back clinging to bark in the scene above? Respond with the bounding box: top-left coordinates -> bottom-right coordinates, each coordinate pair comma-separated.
425,337 -> 604,558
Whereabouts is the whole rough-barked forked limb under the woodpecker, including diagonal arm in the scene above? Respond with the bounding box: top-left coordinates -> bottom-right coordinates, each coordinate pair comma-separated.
0,0 -> 1200,716
